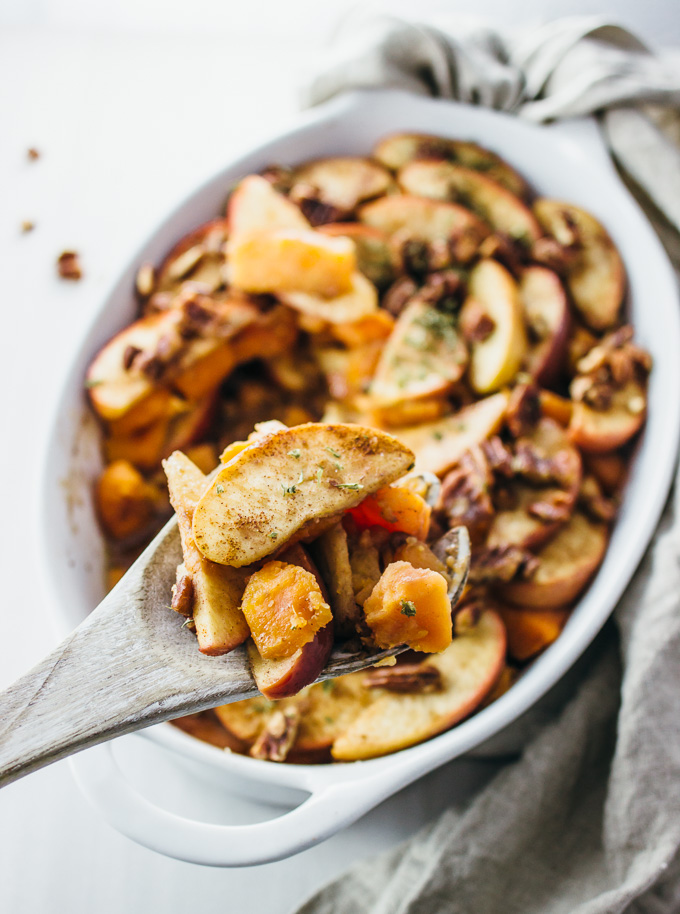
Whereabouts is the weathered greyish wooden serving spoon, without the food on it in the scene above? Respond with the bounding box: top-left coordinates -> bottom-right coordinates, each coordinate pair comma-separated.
0,518 -> 470,787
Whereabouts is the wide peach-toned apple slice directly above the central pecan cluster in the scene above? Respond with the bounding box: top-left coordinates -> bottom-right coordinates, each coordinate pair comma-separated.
359,194 -> 489,243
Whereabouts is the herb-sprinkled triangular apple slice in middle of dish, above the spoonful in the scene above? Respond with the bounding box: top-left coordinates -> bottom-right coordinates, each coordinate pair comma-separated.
370,298 -> 467,406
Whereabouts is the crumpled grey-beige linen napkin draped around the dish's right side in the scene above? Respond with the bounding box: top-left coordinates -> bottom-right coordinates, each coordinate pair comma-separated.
301,18 -> 680,914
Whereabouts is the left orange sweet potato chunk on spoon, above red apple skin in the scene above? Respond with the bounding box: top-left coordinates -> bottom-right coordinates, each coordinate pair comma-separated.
241,561 -> 332,659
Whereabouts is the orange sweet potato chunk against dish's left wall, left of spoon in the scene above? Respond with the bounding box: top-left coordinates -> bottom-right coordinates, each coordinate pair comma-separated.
96,460 -> 157,539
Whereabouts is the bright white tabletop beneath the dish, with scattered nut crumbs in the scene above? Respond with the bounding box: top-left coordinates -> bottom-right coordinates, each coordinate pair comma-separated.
0,0 -> 680,914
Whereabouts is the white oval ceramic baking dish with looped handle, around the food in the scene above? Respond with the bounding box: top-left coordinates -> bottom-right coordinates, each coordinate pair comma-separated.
40,91 -> 680,866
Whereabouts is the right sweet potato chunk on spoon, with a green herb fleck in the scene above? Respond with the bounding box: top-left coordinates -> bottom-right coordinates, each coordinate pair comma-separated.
364,562 -> 452,653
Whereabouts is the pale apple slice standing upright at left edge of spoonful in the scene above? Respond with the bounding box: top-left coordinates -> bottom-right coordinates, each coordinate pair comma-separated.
163,451 -> 250,656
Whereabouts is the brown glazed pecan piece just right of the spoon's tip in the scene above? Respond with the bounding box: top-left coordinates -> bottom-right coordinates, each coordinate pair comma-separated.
439,446 -> 494,542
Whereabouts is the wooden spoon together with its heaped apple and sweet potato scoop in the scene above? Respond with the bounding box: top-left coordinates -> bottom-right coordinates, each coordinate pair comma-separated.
0,422 -> 470,786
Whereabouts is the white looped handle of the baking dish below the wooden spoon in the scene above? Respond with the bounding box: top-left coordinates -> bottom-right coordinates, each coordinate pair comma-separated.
71,744 -> 390,867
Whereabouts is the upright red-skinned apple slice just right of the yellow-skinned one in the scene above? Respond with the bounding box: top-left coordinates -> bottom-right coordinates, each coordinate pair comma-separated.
519,266 -> 571,386
